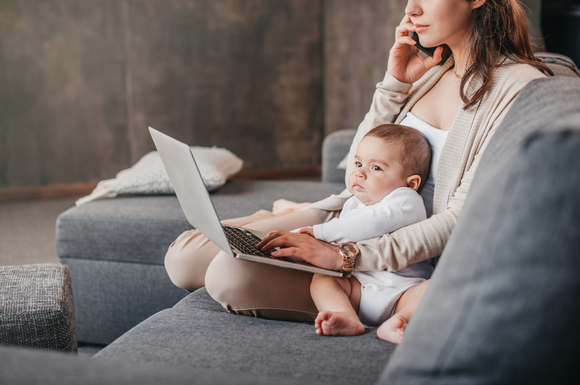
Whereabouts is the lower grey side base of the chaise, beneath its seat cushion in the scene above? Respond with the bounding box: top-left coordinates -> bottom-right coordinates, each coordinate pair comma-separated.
61,258 -> 188,345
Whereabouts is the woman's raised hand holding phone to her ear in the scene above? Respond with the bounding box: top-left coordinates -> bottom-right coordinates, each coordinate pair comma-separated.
387,15 -> 443,84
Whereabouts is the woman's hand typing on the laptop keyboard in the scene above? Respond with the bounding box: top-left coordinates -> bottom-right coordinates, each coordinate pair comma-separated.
256,231 -> 342,271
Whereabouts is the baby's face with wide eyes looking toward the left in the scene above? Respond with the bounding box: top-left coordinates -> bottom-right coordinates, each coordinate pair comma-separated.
348,136 -> 407,206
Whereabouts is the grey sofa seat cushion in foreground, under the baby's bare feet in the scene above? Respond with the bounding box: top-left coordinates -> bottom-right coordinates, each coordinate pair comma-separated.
94,288 -> 394,385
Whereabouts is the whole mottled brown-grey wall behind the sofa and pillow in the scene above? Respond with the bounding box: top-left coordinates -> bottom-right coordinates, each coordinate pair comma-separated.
0,0 -> 540,188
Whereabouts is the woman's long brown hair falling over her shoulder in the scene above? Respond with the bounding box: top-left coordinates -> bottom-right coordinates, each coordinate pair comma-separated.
460,0 -> 554,109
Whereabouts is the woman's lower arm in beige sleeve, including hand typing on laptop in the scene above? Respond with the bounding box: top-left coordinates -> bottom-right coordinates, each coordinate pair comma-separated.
263,65 -> 543,271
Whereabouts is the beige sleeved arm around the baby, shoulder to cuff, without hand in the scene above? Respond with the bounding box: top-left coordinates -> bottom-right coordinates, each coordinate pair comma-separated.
355,65 -> 543,271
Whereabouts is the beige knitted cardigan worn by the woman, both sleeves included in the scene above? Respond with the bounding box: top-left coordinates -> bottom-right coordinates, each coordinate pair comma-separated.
311,58 -> 544,271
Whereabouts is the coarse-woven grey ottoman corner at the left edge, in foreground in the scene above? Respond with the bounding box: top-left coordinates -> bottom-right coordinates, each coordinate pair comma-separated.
0,264 -> 77,352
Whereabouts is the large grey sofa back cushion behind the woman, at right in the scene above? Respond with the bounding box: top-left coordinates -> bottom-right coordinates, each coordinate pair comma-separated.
382,78 -> 580,385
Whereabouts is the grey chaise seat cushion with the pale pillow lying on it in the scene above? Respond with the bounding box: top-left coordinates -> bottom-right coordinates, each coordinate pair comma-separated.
56,180 -> 344,264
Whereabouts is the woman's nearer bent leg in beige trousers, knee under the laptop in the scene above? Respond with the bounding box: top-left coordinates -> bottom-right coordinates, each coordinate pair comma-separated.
205,209 -> 338,322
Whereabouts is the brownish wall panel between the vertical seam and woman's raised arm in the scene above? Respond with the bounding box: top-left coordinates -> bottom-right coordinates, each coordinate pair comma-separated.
324,0 -> 407,134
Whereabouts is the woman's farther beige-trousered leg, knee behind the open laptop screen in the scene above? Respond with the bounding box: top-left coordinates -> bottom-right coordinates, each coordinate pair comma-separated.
165,210 -> 274,291
